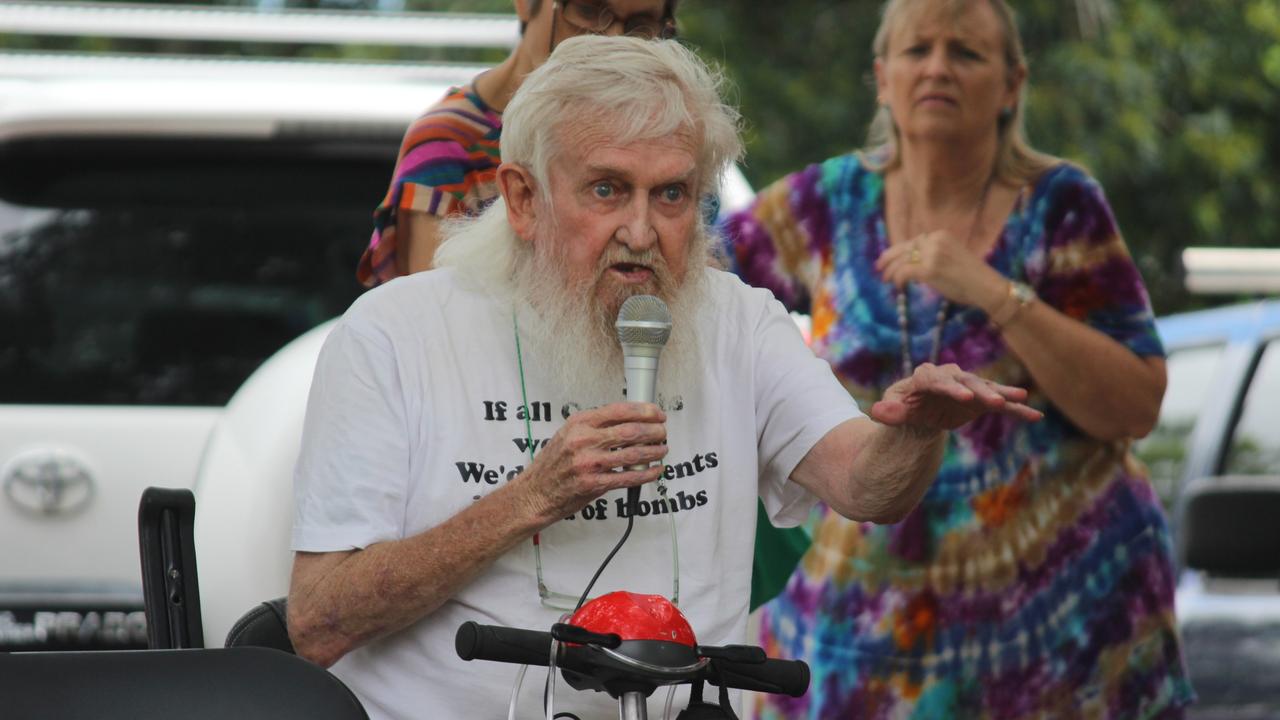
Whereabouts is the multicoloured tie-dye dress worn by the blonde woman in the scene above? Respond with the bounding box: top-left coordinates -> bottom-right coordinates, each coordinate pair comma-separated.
724,155 -> 1192,719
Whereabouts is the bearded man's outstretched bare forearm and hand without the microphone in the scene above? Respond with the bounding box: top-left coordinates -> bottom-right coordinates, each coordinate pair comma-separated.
791,364 -> 1042,523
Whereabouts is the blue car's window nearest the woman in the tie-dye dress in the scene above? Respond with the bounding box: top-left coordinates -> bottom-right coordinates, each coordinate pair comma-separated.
1135,345 -> 1224,510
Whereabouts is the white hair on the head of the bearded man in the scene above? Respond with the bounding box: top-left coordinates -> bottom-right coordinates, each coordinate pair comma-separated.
434,35 -> 742,288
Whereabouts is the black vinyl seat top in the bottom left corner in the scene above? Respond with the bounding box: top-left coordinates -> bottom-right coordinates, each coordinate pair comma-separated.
0,647 -> 369,720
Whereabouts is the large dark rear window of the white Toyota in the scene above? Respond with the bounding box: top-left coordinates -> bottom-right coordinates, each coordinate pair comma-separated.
0,134 -> 396,405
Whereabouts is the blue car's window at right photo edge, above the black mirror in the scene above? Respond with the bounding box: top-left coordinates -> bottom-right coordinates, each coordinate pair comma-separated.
1222,340 -> 1280,475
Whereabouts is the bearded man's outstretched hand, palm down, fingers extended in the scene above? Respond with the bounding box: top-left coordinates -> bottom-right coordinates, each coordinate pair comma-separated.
872,363 -> 1044,430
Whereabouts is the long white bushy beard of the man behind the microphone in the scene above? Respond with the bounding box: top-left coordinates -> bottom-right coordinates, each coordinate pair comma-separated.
511,223 -> 712,407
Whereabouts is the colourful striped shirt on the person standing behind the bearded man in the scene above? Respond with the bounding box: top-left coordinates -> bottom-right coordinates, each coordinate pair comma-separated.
356,87 -> 502,287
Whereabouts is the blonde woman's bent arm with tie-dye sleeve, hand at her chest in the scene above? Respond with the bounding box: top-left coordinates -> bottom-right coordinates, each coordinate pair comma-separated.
877,170 -> 1166,439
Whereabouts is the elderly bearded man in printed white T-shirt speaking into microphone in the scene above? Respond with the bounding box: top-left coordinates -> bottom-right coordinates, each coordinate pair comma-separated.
288,37 -> 1038,719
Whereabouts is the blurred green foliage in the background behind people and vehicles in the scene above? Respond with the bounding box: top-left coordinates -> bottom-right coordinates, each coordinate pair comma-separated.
0,0 -> 1280,314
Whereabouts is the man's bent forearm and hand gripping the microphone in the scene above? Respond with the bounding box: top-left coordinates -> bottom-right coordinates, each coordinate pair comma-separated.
288,402 -> 667,667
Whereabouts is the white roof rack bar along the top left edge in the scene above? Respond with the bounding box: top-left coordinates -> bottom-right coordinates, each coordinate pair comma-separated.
0,3 -> 520,49
